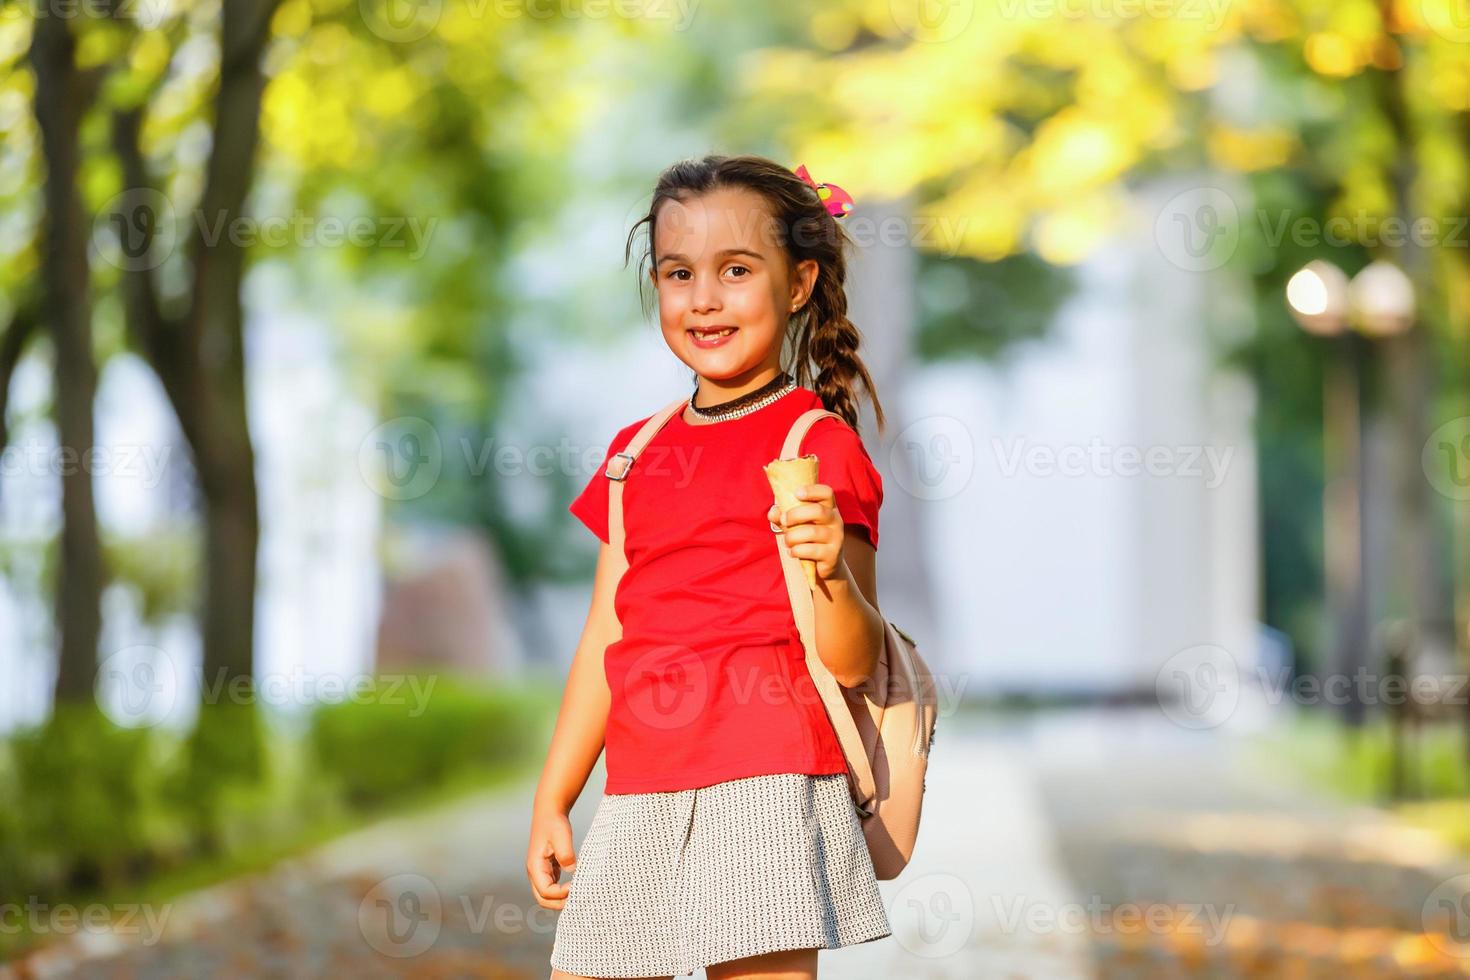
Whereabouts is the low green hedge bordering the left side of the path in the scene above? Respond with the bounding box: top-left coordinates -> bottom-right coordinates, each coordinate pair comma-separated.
0,674 -> 556,961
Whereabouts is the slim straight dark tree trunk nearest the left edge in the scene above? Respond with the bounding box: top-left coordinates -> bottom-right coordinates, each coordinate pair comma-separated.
31,16 -> 103,702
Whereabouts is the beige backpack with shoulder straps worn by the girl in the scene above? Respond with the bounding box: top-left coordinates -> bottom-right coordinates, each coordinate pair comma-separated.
606,398 -> 938,882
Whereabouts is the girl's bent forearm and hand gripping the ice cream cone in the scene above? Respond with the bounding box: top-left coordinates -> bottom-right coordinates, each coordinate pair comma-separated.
767,483 -> 883,688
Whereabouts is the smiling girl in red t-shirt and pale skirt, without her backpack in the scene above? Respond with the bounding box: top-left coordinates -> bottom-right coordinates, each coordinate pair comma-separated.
526,156 -> 891,980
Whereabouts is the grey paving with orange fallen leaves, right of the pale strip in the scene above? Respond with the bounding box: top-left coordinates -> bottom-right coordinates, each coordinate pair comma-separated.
1022,711 -> 1470,979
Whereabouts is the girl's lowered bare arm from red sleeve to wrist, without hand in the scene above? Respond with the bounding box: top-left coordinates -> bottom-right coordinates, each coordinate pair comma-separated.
534,544 -> 628,813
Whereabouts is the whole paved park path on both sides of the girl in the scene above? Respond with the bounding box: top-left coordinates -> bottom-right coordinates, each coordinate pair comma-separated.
11,711 -> 1470,980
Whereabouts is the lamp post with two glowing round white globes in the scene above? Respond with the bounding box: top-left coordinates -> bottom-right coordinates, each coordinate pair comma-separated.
1286,259 -> 1414,727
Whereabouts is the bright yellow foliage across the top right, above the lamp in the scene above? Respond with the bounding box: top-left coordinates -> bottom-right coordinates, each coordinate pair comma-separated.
758,0 -> 1470,274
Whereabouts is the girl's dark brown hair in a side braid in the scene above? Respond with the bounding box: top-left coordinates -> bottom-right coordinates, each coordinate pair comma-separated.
623,154 -> 883,433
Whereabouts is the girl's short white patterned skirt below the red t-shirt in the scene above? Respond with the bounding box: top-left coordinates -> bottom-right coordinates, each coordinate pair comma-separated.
551,773 -> 892,977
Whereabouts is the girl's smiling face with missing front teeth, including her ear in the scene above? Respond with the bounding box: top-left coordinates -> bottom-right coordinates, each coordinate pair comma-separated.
650,188 -> 817,401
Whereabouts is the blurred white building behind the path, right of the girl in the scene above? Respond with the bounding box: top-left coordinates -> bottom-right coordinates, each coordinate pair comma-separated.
889,188 -> 1260,695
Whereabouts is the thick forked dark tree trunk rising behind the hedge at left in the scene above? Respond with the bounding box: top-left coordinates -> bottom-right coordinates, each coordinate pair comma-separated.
113,0 -> 279,808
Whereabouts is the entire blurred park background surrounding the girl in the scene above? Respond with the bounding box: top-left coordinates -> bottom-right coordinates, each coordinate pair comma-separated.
0,0 -> 1470,980
